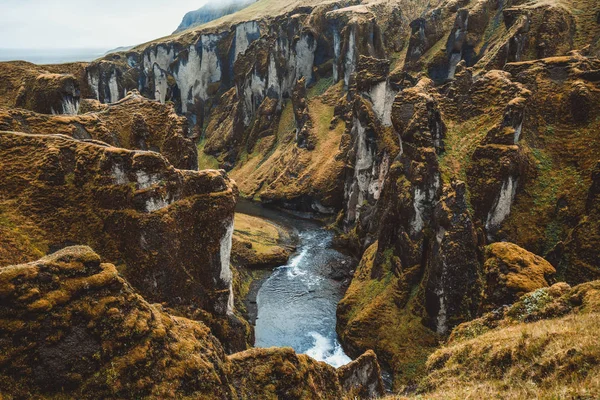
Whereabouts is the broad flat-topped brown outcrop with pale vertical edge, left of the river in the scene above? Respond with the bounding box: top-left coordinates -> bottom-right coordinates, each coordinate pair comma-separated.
0,132 -> 243,340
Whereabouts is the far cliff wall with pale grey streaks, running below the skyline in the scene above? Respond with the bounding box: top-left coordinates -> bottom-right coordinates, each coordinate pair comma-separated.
84,0 -> 600,219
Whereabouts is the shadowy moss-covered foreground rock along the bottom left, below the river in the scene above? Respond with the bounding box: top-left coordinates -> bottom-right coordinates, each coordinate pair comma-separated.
0,246 -> 382,399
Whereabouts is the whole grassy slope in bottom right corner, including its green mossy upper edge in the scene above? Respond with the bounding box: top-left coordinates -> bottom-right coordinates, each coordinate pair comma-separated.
390,281 -> 600,400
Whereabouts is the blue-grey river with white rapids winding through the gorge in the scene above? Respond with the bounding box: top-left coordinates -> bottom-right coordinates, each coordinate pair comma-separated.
238,204 -> 352,367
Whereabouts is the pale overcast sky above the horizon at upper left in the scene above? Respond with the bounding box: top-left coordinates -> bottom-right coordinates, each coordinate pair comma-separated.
0,0 -> 209,50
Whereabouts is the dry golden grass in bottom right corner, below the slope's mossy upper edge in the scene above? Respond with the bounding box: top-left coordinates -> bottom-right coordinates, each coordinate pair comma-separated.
397,313 -> 600,399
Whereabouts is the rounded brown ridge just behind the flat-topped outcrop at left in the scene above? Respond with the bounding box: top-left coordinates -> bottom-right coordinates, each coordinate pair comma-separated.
0,92 -> 198,170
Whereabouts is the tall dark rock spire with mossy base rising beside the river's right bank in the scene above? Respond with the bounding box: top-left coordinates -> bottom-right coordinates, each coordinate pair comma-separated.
338,75 -> 474,379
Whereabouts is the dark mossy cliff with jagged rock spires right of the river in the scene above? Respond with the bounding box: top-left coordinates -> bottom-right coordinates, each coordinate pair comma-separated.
338,54 -> 598,388
